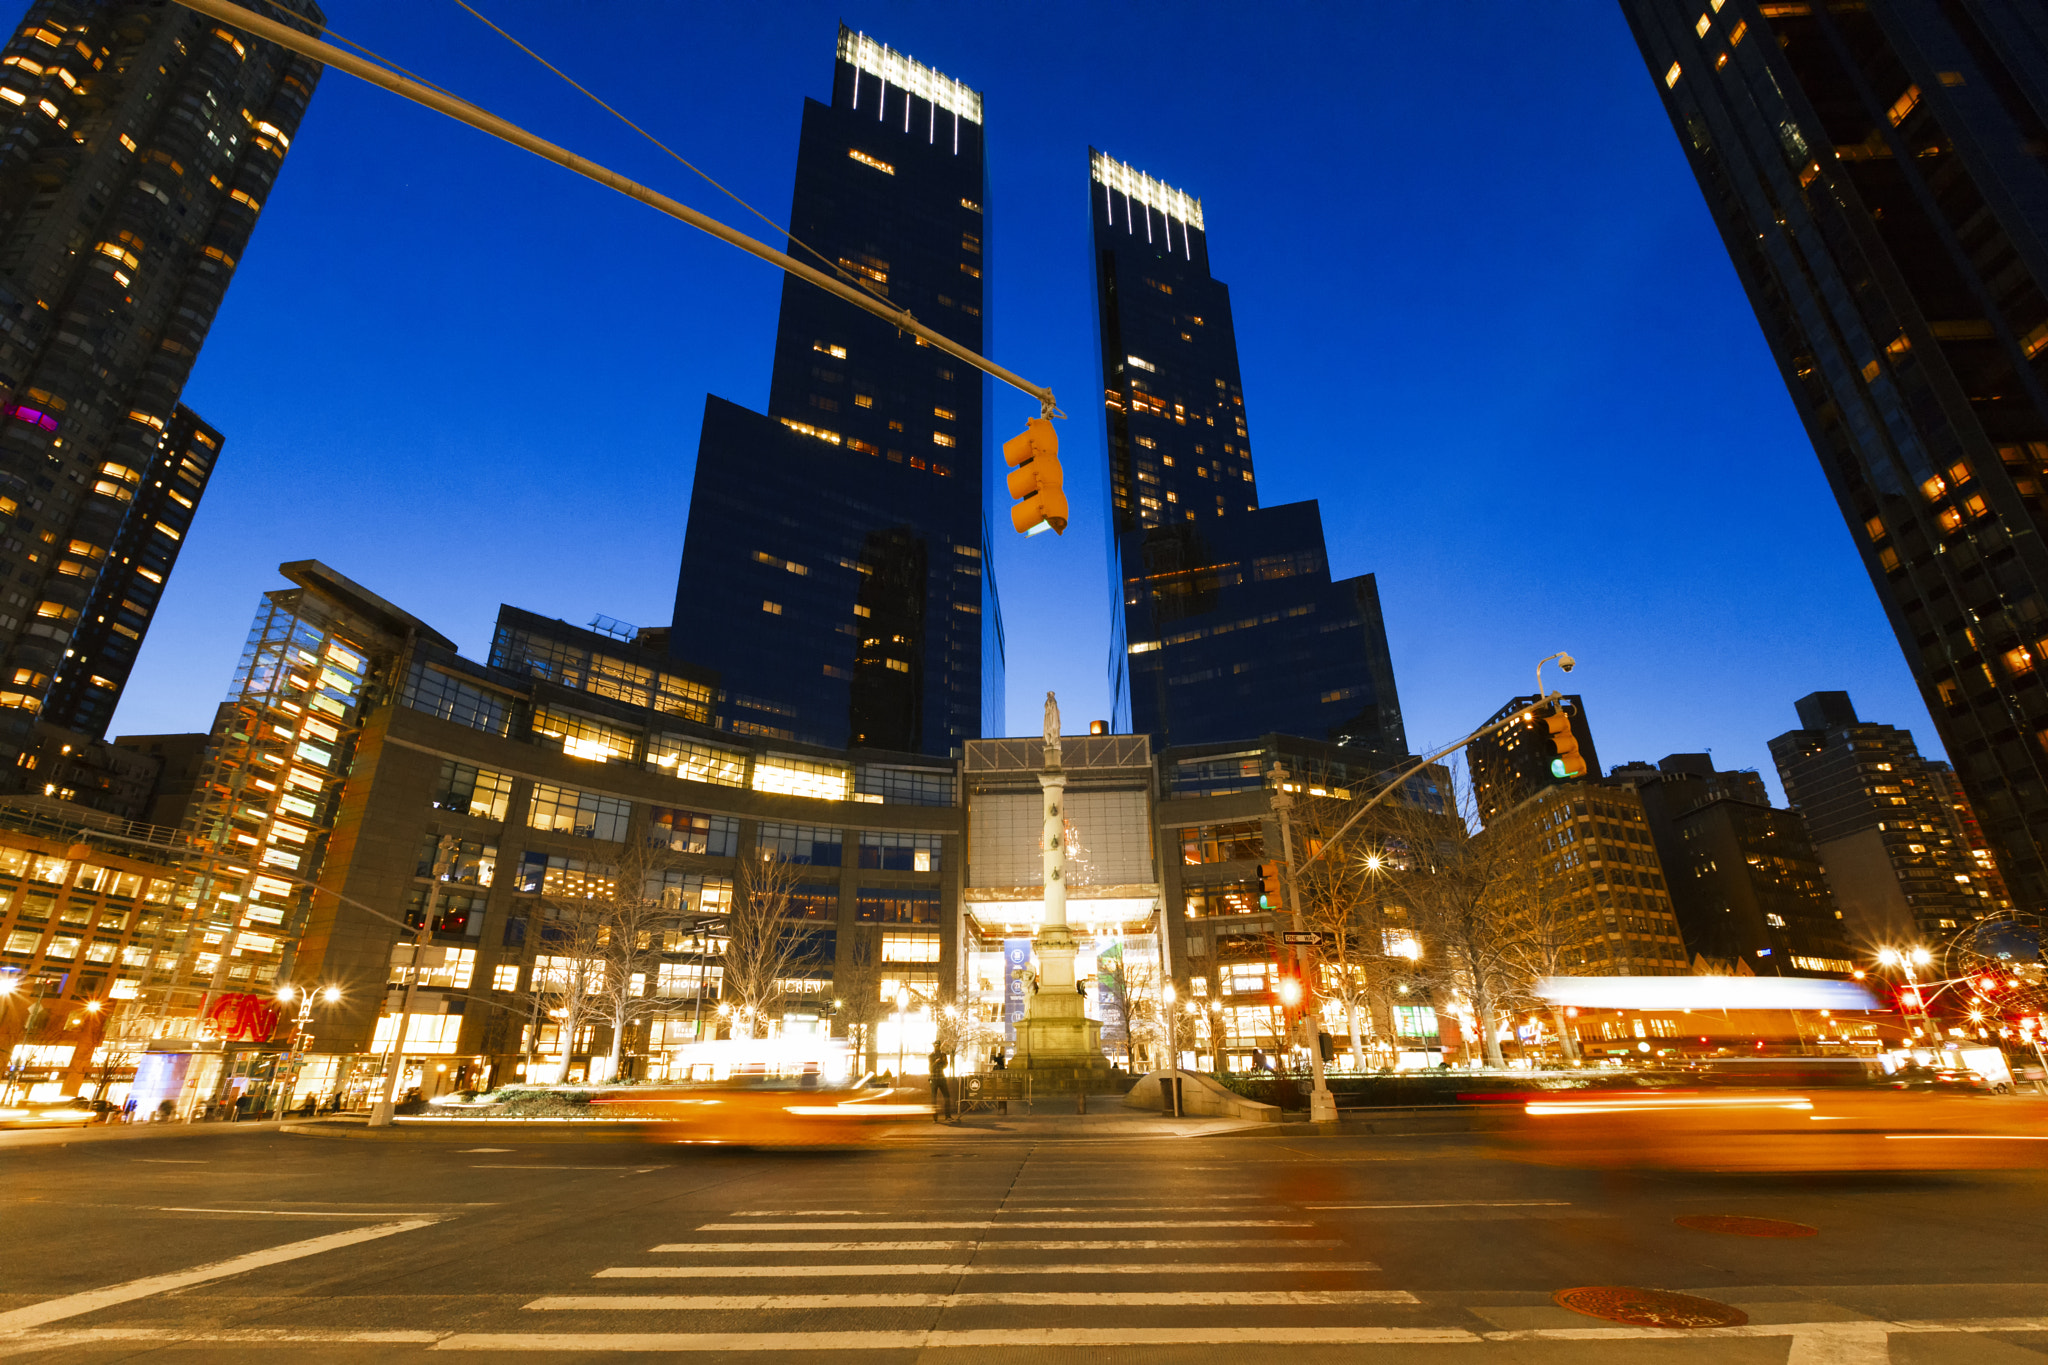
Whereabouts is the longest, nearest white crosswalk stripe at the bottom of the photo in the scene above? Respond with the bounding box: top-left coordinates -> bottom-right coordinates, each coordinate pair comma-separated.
432,1324 -> 1485,1353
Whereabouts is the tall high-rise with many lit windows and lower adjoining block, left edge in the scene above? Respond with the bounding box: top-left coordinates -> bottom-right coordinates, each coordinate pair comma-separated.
0,0 -> 322,773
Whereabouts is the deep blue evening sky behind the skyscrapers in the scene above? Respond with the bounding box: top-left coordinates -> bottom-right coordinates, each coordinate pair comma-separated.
72,0 -> 1937,790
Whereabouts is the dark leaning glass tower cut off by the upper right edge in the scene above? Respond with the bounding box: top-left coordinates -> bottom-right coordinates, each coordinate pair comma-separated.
1622,0 -> 2048,911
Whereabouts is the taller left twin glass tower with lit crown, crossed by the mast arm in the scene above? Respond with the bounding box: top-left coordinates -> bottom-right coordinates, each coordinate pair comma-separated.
670,29 -> 1004,753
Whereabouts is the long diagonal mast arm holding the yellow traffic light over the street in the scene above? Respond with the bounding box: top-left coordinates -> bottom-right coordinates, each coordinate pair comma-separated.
178,0 -> 1063,417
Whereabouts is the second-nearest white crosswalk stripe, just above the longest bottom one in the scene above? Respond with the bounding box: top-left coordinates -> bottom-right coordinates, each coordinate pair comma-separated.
526,1289 -> 1419,1312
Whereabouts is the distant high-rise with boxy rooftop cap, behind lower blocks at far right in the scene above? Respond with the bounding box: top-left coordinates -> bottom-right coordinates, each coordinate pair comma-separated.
1772,692 -> 2011,950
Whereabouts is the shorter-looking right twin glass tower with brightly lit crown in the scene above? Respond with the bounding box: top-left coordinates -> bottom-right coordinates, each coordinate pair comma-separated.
1090,151 -> 1407,755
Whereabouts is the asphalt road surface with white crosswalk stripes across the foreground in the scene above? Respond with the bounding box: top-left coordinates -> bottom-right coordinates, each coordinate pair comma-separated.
0,1128 -> 2048,1365
